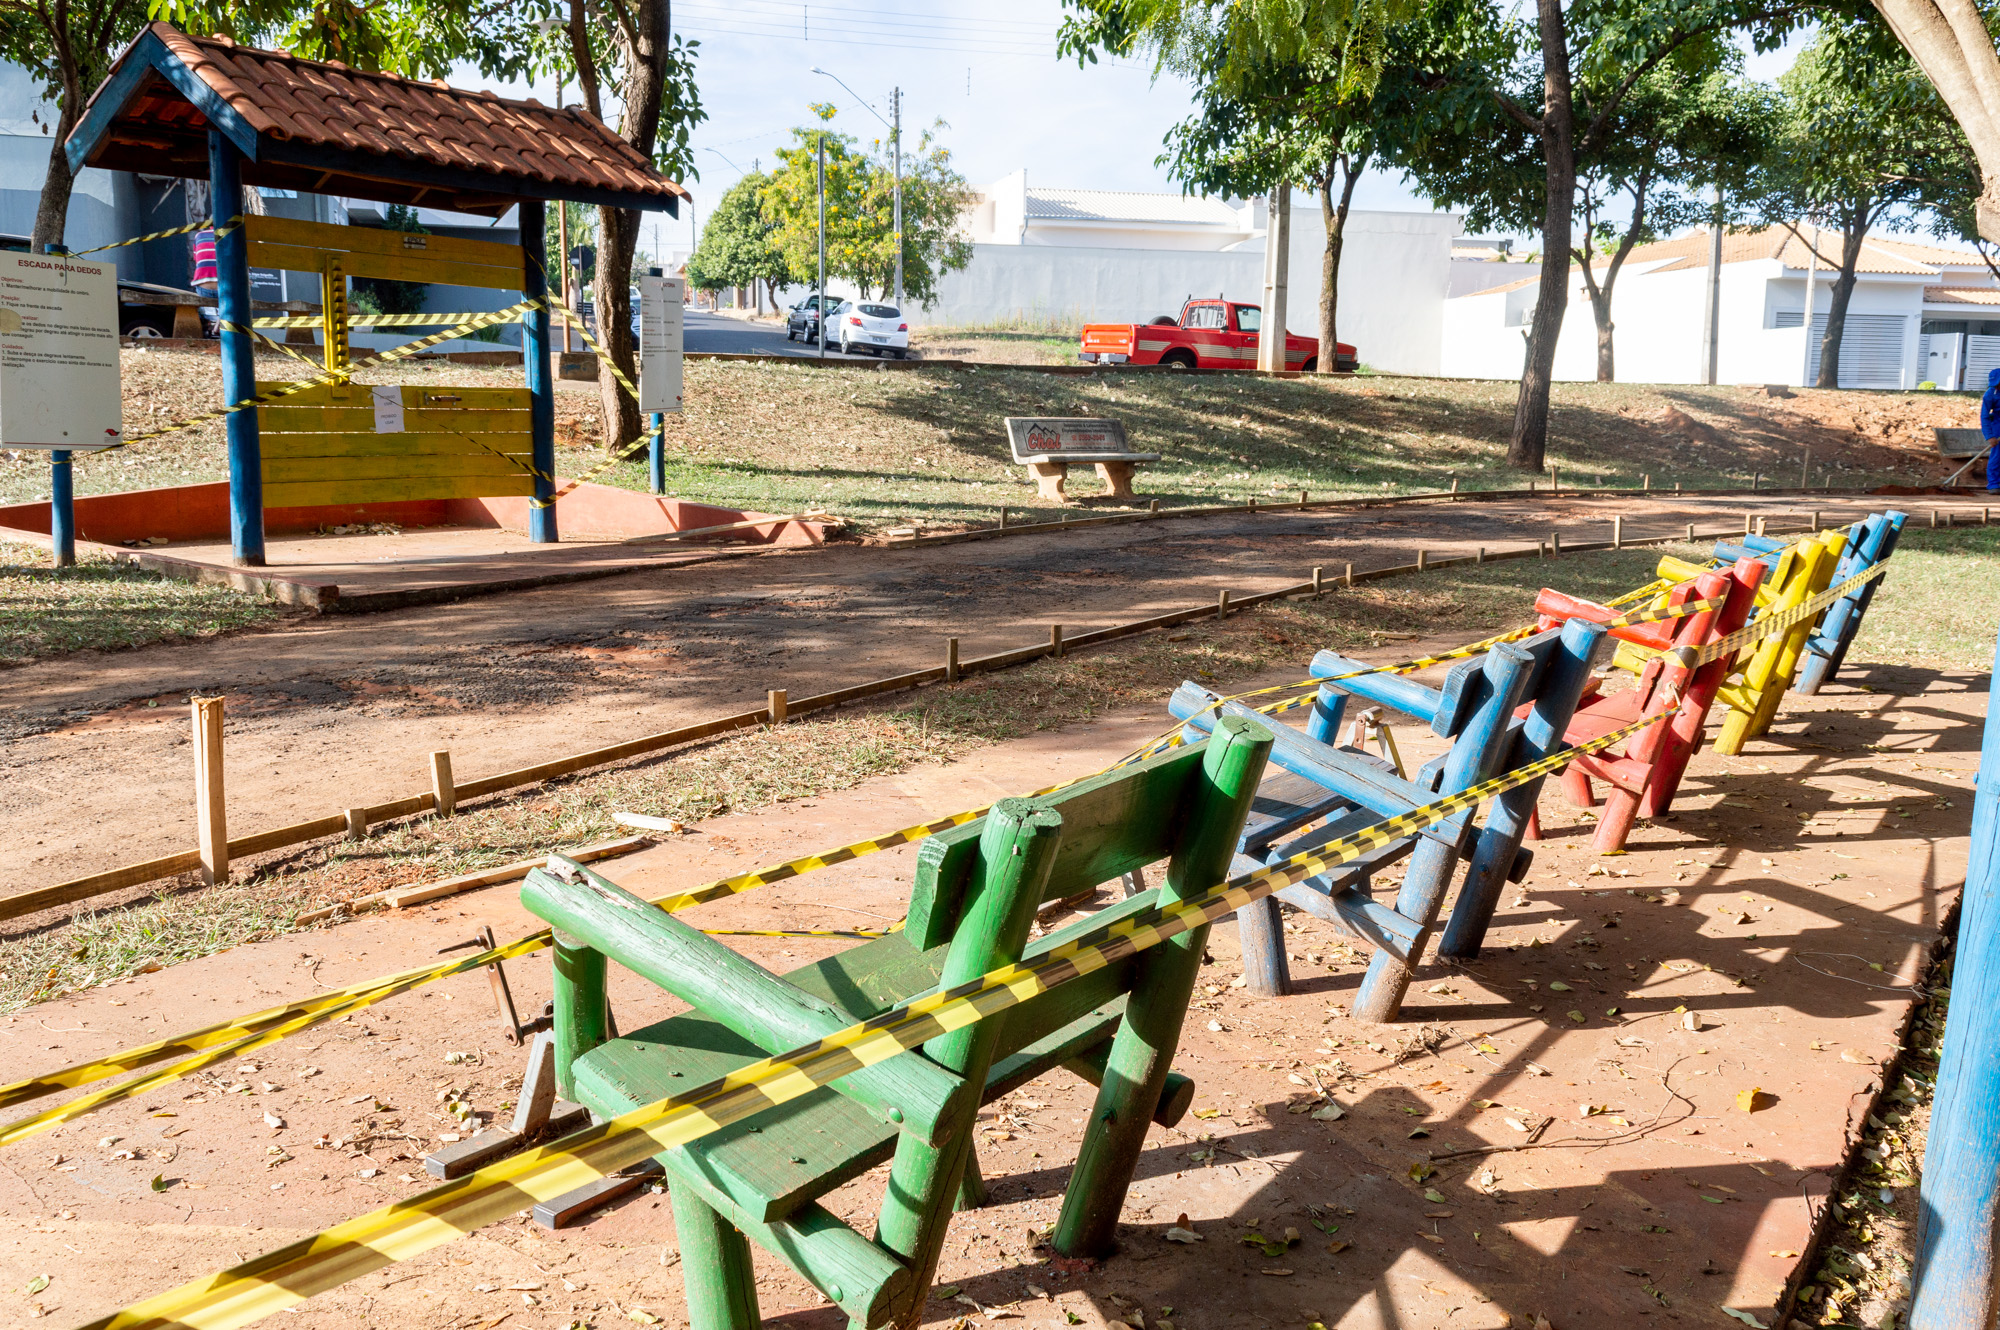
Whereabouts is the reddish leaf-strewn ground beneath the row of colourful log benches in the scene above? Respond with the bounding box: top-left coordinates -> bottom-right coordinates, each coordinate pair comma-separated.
0,612 -> 1986,1330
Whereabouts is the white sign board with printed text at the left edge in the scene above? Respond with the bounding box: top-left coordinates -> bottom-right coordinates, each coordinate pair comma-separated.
0,254 -> 124,450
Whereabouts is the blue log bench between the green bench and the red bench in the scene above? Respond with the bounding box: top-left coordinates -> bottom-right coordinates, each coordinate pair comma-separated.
1168,620 -> 1604,1020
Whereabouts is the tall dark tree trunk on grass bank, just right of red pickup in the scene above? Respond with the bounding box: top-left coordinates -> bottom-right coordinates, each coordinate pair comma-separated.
1506,0 -> 1576,472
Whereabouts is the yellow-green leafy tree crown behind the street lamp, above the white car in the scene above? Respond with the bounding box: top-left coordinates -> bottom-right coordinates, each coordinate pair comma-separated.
758,106 -> 972,304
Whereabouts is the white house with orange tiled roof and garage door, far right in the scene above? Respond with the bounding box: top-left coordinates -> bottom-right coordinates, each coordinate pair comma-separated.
1442,226 -> 2000,388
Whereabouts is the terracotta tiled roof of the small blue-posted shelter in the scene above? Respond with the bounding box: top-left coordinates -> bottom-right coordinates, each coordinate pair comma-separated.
76,22 -> 688,209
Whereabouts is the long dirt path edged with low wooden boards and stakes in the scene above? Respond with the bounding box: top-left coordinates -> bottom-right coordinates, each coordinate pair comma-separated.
0,496 -> 1976,894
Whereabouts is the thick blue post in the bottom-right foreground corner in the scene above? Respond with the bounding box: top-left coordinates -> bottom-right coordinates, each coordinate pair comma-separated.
1910,628 -> 2000,1330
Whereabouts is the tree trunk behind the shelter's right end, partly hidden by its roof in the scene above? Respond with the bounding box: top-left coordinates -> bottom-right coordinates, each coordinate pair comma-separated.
592,0 -> 672,446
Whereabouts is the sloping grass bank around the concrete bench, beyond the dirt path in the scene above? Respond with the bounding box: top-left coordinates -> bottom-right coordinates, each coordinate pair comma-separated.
0,344 -> 1976,532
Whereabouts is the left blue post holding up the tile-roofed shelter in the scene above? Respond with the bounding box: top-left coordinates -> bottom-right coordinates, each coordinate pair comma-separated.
208,130 -> 264,568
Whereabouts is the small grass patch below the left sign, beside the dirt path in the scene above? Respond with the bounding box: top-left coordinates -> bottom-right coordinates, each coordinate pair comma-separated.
0,540 -> 286,666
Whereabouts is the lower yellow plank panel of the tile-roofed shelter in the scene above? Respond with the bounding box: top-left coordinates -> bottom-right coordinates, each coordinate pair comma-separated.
258,384 -> 534,508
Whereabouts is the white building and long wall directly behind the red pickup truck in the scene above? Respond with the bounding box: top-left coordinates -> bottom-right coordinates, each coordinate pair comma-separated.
924,170 -> 1460,374
